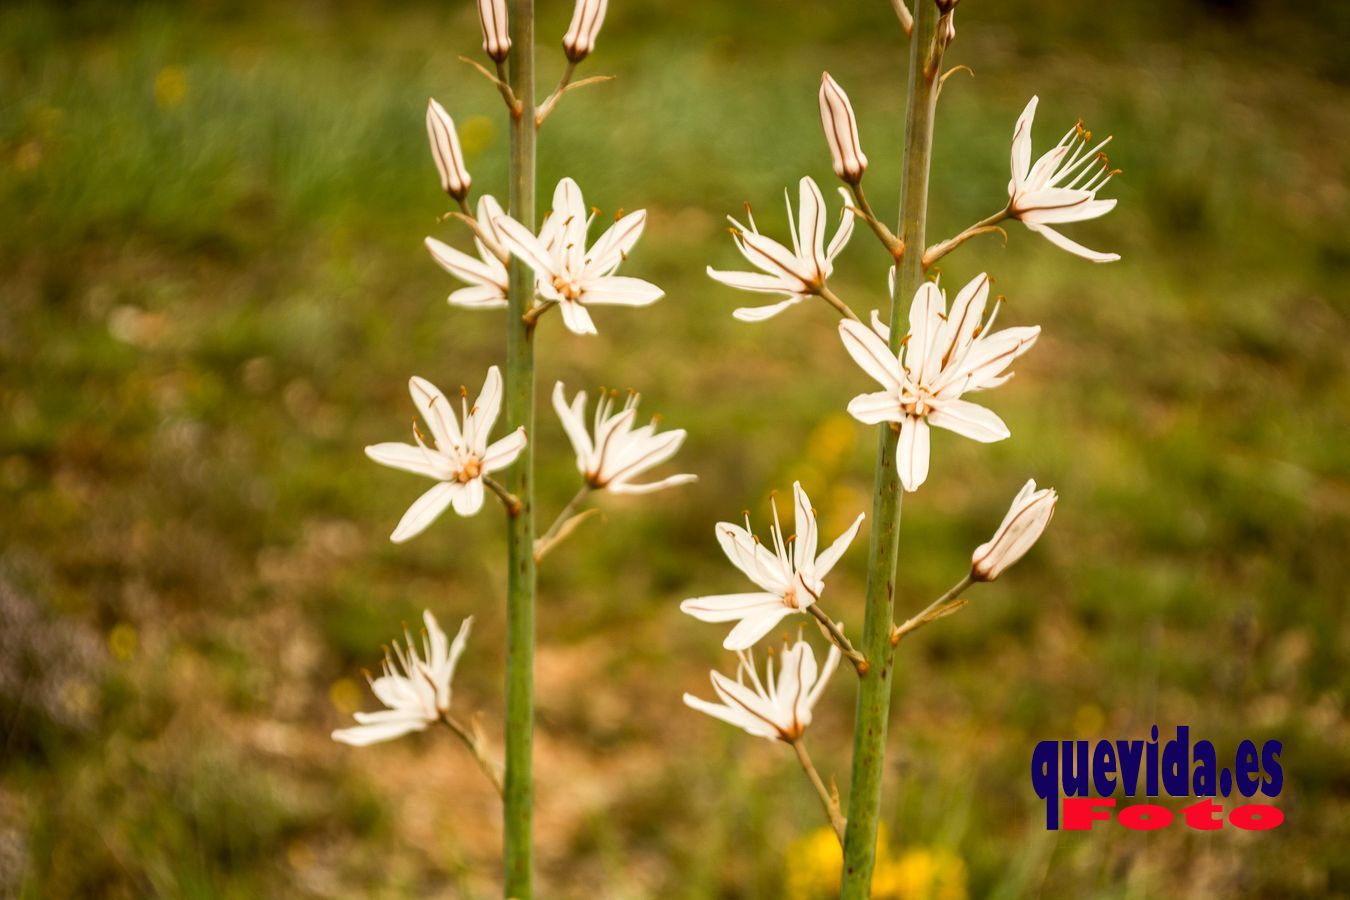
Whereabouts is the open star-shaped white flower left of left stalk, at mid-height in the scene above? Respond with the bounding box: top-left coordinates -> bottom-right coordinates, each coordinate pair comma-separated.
366,366 -> 525,544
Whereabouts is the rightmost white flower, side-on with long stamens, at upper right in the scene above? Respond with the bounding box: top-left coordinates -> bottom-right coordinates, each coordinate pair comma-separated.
1008,97 -> 1121,263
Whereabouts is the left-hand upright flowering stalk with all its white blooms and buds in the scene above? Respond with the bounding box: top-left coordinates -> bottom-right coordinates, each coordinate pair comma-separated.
333,0 -> 694,900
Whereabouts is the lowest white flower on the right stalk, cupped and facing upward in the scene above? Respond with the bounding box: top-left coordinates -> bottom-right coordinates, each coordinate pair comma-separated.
684,637 -> 841,743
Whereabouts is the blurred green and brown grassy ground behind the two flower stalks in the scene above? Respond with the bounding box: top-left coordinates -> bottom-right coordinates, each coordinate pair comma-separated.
0,0 -> 1350,897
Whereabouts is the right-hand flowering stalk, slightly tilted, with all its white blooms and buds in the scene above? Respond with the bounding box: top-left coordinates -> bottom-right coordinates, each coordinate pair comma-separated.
682,0 -> 1118,900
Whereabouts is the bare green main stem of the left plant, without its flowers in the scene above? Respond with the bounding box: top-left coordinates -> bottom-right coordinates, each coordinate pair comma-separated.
502,0 -> 535,900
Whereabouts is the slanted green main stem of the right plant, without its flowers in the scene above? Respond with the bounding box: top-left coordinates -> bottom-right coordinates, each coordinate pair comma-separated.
840,0 -> 942,900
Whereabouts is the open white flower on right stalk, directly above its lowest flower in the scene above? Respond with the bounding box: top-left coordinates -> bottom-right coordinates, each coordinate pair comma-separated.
679,483 -> 863,650
